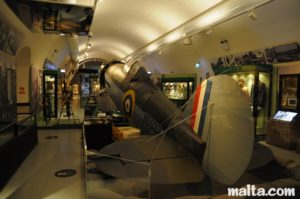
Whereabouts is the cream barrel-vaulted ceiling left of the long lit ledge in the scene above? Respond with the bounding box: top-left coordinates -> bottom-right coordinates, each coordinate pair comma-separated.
79,0 -> 221,60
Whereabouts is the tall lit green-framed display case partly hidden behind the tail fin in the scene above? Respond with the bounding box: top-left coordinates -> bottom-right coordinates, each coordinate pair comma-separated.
215,65 -> 273,135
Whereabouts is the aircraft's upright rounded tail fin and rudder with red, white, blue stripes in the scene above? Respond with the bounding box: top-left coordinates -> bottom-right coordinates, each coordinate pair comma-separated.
185,75 -> 254,184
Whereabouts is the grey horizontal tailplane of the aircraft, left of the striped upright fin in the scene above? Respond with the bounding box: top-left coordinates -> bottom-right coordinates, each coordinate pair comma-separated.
96,136 -> 204,184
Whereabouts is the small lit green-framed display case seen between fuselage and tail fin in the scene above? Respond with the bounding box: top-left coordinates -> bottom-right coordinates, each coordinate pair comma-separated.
161,75 -> 196,106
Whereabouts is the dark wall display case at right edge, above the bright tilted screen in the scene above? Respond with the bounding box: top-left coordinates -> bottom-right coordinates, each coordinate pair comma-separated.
278,75 -> 300,112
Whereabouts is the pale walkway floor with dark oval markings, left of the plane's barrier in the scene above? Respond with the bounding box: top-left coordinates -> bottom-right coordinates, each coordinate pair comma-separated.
0,129 -> 85,199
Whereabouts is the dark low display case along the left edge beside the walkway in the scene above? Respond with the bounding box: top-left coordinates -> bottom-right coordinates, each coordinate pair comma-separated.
0,114 -> 38,191
